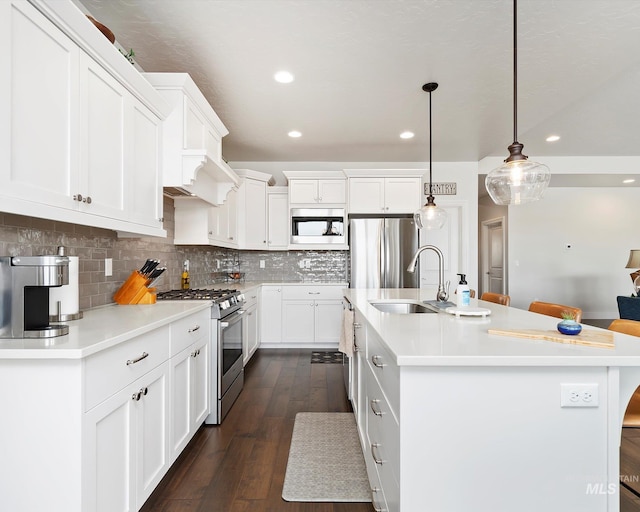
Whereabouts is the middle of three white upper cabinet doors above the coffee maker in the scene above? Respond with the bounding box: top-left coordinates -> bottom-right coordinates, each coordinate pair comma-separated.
77,53 -> 127,220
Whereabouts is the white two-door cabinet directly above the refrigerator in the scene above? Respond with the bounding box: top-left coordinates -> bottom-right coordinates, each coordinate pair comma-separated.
349,176 -> 422,214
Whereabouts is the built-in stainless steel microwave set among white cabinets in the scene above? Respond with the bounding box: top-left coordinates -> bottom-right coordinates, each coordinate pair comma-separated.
291,208 -> 347,244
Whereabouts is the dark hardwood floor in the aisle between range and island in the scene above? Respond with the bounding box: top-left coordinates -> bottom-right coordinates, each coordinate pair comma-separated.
141,349 -> 373,512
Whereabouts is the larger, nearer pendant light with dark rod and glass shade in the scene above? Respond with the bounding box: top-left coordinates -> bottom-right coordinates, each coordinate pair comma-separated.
485,0 -> 551,205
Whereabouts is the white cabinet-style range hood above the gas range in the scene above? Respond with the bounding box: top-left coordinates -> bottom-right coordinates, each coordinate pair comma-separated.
144,73 -> 240,205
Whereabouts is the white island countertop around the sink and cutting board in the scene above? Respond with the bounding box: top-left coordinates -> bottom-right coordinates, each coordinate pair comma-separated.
345,288 -> 640,366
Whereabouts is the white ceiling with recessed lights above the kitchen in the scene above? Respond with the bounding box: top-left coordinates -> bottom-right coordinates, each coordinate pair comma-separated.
80,0 -> 640,166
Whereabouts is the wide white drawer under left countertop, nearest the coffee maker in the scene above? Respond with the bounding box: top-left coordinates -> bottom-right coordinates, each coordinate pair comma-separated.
84,325 -> 169,411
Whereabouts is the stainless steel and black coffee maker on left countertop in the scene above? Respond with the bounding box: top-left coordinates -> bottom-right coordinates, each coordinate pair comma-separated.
0,255 -> 69,338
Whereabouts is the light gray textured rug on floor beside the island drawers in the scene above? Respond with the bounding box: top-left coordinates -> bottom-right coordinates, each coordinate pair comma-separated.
282,412 -> 371,502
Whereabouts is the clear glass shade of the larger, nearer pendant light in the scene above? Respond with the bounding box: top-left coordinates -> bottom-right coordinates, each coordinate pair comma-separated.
484,160 -> 551,205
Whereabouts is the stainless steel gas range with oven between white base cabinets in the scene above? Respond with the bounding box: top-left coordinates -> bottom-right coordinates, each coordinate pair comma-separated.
157,289 -> 244,425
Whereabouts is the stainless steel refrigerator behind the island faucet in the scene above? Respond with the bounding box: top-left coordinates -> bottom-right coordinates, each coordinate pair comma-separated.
349,217 -> 420,288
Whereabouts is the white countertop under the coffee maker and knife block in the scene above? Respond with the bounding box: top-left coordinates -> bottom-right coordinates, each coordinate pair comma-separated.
0,300 -> 211,359
